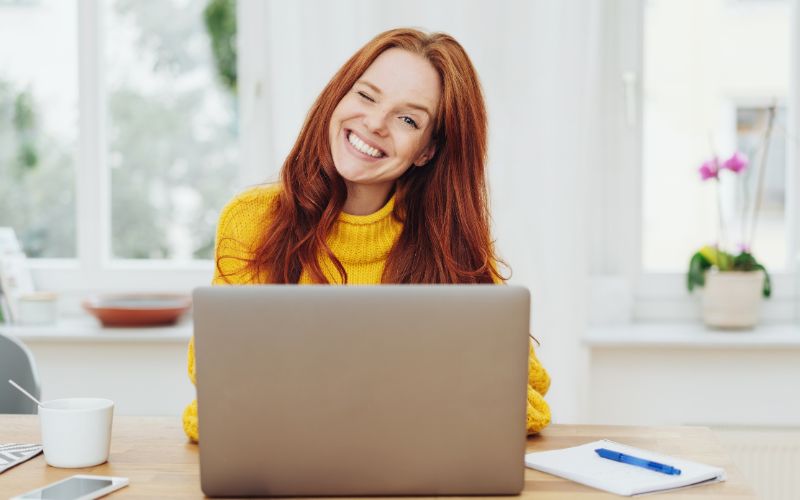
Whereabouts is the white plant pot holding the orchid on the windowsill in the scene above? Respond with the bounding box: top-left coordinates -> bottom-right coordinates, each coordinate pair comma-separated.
703,271 -> 764,329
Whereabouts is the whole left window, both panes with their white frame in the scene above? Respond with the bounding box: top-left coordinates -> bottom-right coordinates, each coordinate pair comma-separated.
0,0 -> 247,293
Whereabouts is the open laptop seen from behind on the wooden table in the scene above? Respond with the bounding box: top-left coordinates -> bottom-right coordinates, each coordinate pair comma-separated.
194,285 -> 530,496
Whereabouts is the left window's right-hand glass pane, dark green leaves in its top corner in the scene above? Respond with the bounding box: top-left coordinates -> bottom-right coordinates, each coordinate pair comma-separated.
104,0 -> 238,261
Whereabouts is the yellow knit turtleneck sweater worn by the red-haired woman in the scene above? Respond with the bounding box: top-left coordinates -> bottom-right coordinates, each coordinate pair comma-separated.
183,185 -> 550,441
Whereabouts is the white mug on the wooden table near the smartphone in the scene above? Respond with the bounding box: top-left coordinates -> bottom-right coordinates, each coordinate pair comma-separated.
39,398 -> 114,468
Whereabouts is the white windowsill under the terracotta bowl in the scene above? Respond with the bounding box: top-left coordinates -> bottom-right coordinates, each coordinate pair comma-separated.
0,316 -> 193,343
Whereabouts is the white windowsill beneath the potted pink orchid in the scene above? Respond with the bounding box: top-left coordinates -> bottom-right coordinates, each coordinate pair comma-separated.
583,322 -> 800,349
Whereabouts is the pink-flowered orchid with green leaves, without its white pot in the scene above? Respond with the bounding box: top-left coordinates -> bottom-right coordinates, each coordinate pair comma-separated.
687,151 -> 772,297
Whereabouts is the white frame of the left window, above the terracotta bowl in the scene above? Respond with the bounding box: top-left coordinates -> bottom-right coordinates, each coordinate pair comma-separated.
29,0 -> 272,295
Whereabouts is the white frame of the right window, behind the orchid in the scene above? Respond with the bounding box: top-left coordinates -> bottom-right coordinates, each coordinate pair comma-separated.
590,0 -> 800,324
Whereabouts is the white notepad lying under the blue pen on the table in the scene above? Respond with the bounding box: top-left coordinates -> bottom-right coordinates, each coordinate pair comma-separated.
525,439 -> 725,496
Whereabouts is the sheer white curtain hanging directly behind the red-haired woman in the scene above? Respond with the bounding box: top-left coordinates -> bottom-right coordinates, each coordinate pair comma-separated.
247,0 -> 600,422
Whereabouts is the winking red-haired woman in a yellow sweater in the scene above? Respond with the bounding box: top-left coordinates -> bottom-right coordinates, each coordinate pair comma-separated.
183,29 -> 550,441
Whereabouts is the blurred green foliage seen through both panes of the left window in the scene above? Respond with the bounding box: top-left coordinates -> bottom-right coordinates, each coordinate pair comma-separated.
0,0 -> 238,259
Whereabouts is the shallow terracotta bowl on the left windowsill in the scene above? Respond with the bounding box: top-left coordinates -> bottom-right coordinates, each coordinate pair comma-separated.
83,293 -> 192,327
